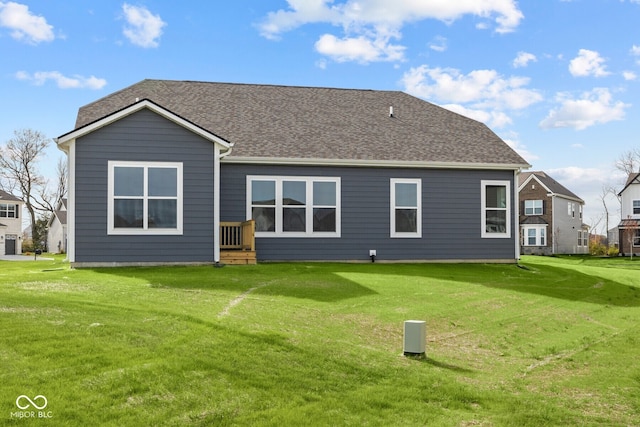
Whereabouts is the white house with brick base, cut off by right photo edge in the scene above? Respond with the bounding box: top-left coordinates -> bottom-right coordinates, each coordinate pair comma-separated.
618,173 -> 640,255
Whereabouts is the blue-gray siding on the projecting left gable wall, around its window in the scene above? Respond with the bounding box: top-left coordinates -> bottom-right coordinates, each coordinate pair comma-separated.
75,110 -> 214,263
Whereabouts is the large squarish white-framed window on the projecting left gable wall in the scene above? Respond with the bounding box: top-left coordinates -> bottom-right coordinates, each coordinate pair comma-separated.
107,161 -> 183,235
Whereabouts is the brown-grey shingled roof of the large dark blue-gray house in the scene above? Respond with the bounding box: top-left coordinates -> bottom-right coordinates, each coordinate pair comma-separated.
71,80 -> 528,168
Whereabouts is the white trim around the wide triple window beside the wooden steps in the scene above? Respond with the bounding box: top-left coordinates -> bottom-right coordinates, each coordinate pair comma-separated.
246,175 -> 342,238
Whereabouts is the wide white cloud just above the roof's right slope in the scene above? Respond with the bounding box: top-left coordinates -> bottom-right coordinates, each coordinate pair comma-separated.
402,65 -> 542,127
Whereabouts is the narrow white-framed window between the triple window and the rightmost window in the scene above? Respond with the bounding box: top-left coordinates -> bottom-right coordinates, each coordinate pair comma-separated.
390,178 -> 422,238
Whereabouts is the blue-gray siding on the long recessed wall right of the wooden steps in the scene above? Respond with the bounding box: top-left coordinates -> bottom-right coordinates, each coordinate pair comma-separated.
220,163 -> 518,261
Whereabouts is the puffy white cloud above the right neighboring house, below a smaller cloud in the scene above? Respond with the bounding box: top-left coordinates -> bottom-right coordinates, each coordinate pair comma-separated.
540,88 -> 629,130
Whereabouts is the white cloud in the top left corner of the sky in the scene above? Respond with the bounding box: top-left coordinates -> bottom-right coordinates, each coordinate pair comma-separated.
0,2 -> 55,44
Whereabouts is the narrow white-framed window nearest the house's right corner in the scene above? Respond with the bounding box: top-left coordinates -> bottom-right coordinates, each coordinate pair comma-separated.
480,180 -> 511,238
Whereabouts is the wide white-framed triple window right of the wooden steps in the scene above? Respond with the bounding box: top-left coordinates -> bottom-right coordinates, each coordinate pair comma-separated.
247,176 -> 341,237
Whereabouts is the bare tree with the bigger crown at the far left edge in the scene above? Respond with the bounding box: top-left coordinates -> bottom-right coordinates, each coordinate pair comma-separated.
0,129 -> 49,251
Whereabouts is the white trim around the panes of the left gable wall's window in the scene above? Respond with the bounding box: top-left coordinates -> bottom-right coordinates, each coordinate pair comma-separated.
107,160 -> 183,236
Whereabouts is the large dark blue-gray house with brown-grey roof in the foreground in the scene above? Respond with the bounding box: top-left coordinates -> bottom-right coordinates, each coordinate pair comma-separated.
57,80 -> 529,266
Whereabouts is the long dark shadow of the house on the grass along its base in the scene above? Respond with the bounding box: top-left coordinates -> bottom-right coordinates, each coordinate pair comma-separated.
85,263 -> 640,307
